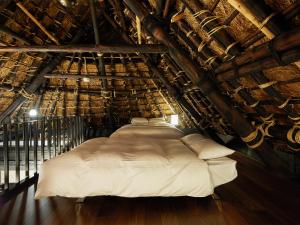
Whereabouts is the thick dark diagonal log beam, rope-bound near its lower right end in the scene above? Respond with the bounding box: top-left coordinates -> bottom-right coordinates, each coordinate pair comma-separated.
124,0 -> 284,172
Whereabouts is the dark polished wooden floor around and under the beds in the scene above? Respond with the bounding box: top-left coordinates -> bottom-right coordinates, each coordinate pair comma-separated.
0,154 -> 300,225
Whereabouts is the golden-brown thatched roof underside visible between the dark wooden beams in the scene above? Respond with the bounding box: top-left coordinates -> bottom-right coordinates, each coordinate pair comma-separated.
0,0 -> 300,151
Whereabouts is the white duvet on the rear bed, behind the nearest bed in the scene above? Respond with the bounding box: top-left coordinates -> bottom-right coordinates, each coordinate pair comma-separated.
110,123 -> 184,139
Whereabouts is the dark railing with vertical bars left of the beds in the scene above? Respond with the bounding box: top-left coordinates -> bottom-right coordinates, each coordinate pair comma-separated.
0,117 -> 85,193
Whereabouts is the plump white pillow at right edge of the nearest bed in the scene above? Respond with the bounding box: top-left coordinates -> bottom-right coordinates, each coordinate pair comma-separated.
181,134 -> 234,159
